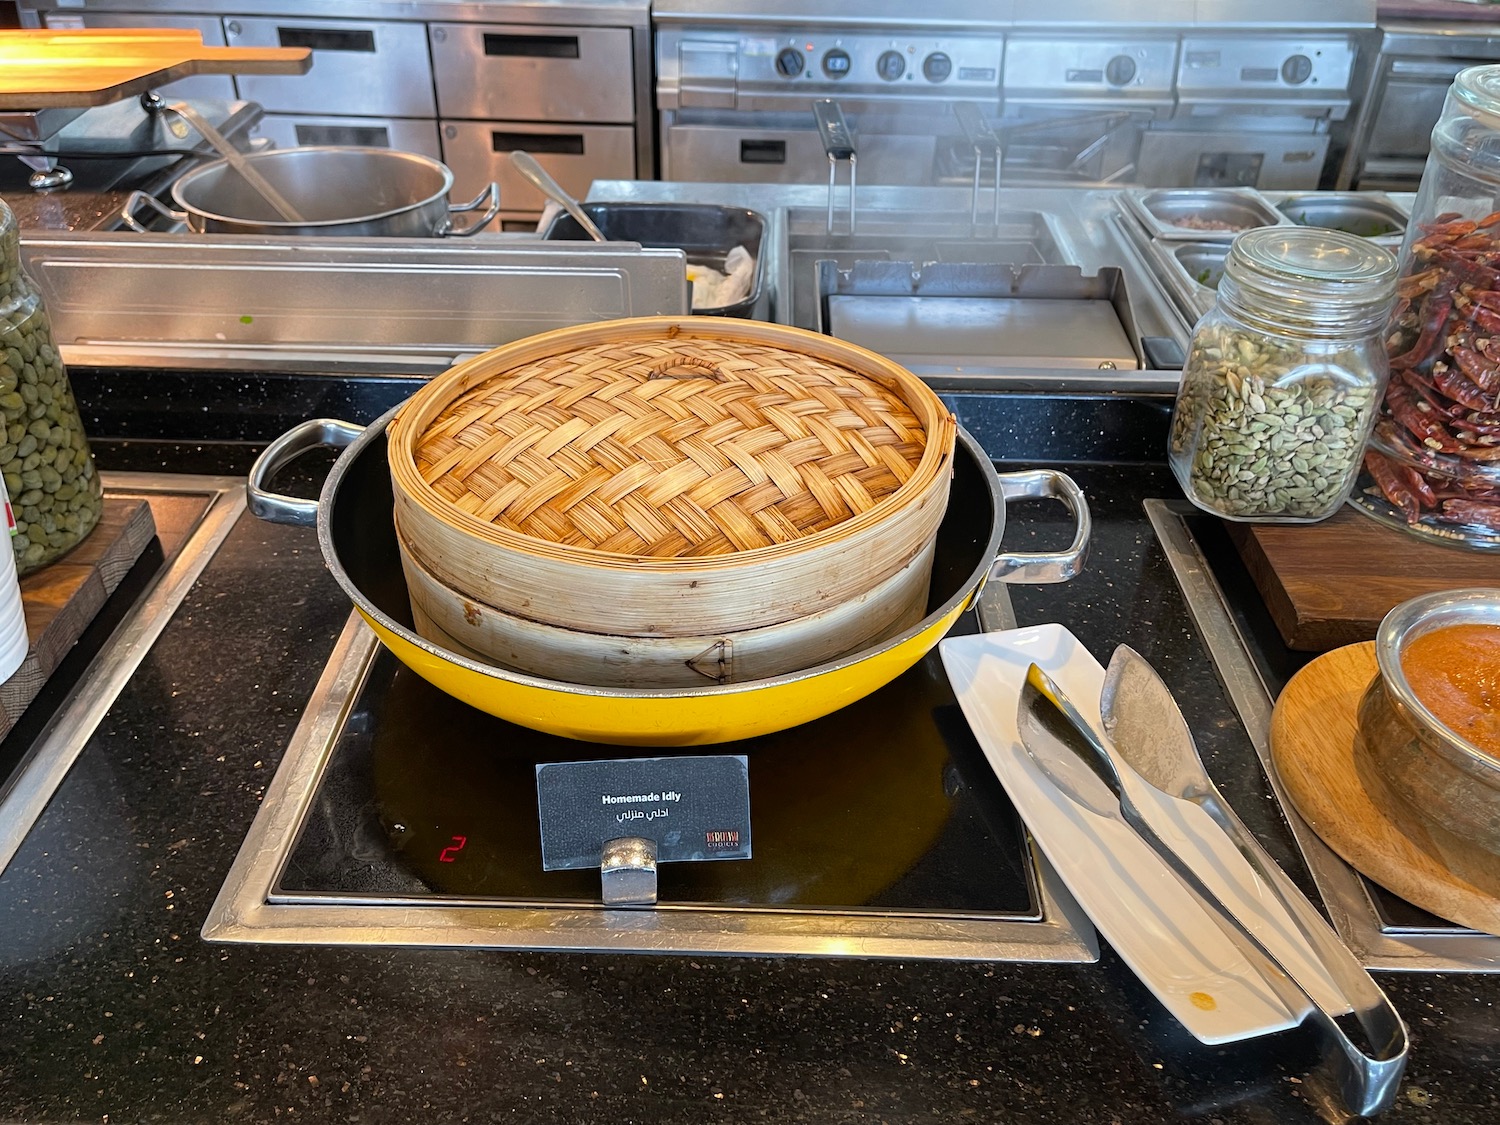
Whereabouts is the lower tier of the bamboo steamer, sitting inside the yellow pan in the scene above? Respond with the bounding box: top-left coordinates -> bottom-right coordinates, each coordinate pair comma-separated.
399,542 -> 935,689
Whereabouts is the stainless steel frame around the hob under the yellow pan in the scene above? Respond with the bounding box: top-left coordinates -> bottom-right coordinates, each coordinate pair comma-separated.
203,615 -> 1100,962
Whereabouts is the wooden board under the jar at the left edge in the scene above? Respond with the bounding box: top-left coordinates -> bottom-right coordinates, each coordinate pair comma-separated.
0,497 -> 156,737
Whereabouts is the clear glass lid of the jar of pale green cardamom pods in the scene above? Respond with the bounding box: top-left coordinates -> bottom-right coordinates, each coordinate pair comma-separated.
1220,227 -> 1397,332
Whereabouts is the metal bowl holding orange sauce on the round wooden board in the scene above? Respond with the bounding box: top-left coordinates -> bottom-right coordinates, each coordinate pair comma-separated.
1355,588 -> 1500,854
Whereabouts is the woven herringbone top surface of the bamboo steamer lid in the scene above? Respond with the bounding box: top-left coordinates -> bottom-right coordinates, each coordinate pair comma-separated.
392,318 -> 954,561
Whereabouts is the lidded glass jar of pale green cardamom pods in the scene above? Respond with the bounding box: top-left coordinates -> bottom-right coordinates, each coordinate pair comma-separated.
1167,227 -> 1397,524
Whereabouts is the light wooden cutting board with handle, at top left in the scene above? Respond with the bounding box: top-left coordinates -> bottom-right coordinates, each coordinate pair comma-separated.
0,29 -> 312,110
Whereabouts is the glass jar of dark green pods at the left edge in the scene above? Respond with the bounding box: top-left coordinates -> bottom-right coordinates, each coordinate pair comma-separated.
0,201 -> 104,575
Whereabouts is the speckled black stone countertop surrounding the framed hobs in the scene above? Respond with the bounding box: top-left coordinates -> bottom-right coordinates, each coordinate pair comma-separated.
0,372 -> 1500,1125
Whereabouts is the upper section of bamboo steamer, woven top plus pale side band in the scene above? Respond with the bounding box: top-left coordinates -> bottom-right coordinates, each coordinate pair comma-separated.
389,317 -> 957,642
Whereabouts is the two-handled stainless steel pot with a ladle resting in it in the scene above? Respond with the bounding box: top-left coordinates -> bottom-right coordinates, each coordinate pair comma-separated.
122,146 -> 500,239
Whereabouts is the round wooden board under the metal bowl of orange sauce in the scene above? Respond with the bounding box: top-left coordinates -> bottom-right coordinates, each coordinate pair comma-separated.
1271,642 -> 1500,935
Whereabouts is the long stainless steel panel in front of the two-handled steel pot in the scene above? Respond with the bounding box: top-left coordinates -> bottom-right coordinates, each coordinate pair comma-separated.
21,231 -> 689,374
